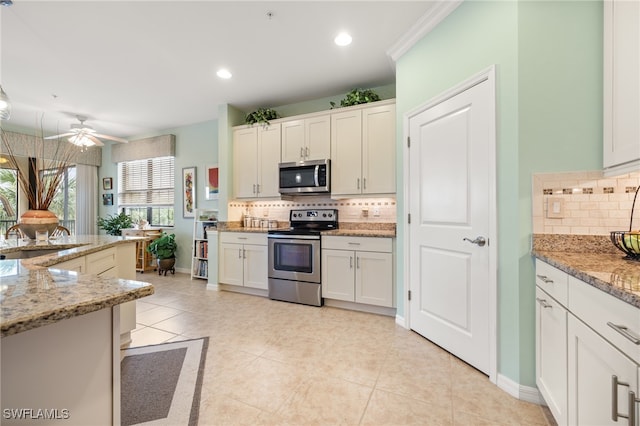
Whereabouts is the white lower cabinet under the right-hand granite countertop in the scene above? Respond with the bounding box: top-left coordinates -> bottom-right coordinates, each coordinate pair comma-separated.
536,260 -> 640,426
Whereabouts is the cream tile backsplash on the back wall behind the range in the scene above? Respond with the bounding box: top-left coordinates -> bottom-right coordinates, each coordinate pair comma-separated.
228,196 -> 396,223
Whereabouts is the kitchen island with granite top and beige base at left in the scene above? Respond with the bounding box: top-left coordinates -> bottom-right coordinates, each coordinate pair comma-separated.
0,236 -> 153,425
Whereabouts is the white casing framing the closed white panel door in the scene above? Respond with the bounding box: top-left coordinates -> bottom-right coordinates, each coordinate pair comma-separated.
402,65 -> 498,383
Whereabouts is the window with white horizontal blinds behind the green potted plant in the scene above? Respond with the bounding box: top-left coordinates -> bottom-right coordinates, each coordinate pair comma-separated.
118,156 -> 175,226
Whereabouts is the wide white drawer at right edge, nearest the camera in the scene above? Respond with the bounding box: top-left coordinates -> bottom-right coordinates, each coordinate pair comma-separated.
569,277 -> 640,364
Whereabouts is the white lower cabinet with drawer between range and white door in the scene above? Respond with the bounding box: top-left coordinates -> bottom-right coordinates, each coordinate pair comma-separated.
322,236 -> 393,307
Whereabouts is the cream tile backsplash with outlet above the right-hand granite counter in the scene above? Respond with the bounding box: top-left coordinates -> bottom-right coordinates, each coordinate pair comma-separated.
533,171 -> 640,235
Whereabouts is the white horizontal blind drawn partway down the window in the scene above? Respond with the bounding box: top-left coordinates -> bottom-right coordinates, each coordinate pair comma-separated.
118,157 -> 175,207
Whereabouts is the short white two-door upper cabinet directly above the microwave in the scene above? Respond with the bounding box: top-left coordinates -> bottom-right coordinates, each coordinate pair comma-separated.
282,114 -> 331,163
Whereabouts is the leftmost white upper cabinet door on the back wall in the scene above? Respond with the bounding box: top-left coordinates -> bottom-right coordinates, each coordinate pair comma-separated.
233,127 -> 258,198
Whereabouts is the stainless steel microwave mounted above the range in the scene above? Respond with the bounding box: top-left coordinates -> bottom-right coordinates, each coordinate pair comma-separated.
279,160 -> 331,195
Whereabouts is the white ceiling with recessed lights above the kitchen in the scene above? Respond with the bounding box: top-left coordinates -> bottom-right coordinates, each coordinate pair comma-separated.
0,0 -> 434,138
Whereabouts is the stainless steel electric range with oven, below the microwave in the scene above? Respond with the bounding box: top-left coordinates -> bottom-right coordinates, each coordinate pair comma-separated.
267,209 -> 338,306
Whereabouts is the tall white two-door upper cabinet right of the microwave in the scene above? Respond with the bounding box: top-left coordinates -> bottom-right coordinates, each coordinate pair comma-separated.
331,102 -> 396,196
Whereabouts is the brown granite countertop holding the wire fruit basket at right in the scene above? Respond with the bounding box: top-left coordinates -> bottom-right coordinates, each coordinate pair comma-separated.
532,235 -> 640,308
